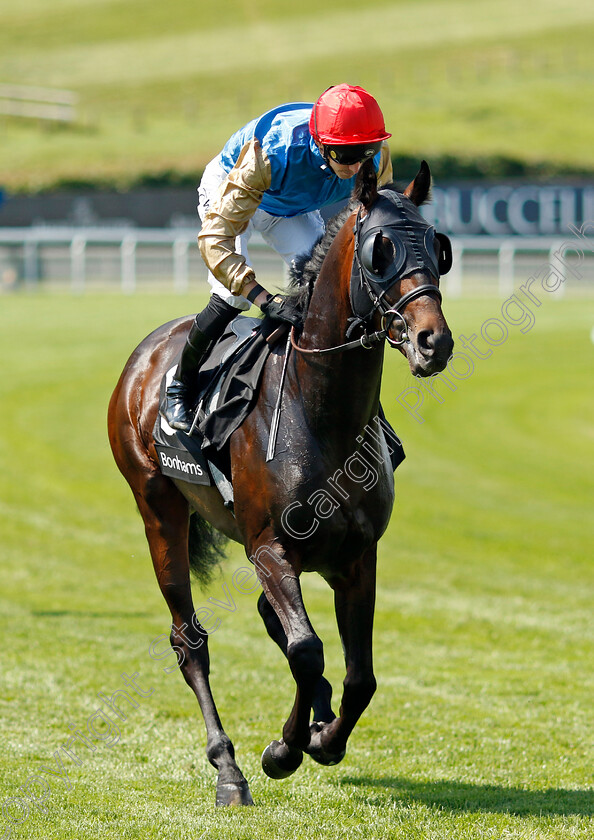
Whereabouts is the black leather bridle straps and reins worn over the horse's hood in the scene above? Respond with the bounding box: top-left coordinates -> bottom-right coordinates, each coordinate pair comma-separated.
290,191 -> 442,356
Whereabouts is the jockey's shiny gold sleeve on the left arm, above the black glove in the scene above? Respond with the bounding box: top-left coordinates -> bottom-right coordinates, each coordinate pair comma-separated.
198,138 -> 272,295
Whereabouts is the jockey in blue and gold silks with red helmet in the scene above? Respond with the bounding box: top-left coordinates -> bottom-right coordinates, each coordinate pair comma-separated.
161,84 -> 392,432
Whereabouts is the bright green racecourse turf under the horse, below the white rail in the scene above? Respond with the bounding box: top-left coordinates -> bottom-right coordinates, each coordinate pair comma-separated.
0,294 -> 594,840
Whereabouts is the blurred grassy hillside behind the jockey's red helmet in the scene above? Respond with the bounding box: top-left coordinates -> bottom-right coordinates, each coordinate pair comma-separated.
0,0 -> 594,189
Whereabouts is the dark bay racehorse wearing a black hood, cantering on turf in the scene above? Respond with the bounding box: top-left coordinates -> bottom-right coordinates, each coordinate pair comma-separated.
109,162 -> 453,805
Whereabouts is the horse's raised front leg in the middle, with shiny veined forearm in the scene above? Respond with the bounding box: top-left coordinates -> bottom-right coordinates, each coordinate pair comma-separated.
252,543 -> 324,779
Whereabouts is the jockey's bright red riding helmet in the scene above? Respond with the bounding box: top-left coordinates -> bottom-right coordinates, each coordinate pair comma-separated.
309,84 -> 392,146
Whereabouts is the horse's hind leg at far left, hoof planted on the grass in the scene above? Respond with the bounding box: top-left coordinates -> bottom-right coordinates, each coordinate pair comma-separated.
135,474 -> 253,805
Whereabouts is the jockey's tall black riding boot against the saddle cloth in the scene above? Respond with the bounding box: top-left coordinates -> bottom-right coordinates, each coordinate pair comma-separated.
160,295 -> 239,432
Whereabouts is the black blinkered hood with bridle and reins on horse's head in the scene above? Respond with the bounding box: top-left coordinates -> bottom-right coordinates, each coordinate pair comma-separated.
291,190 -> 442,356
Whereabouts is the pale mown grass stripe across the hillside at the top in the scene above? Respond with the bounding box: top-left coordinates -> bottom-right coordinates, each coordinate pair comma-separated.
0,0 -> 594,88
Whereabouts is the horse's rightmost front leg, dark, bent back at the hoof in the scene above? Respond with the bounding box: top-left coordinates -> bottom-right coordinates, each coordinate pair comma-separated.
305,545 -> 377,764
